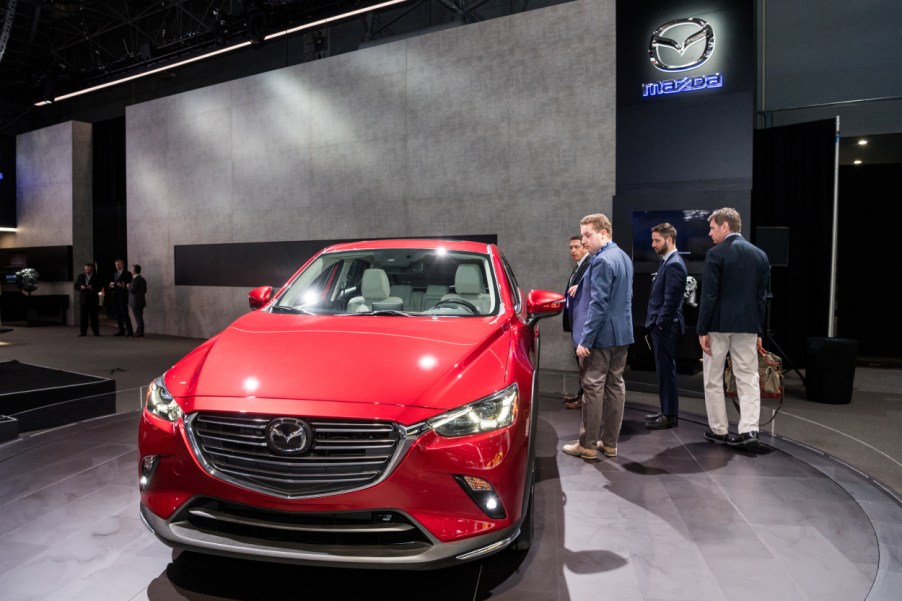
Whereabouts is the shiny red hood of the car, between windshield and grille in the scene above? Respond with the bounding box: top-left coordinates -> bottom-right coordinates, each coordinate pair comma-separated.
166,311 -> 510,415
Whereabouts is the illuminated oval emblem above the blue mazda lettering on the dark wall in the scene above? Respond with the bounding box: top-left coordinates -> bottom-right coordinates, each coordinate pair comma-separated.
648,17 -> 714,72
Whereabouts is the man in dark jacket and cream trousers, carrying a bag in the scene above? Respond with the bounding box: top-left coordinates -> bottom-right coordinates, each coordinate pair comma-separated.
697,208 -> 770,447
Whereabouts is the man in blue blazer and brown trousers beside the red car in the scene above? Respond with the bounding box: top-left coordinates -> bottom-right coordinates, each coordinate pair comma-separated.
563,213 -> 633,460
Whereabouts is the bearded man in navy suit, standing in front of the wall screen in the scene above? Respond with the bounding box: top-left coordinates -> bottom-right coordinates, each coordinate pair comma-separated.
645,223 -> 689,430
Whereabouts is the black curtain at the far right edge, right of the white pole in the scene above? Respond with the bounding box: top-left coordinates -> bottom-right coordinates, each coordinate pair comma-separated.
836,164 -> 902,365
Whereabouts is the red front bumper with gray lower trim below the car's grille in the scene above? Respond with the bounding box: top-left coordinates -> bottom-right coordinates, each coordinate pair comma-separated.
139,412 -> 528,569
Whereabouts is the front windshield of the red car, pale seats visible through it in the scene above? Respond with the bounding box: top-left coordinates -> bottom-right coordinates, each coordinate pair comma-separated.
271,249 -> 499,317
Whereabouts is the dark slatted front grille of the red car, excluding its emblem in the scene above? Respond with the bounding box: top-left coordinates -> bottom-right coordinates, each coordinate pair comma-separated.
185,412 -> 402,498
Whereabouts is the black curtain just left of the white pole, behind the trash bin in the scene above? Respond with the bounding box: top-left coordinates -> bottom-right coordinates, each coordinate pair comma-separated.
746,119 -> 836,368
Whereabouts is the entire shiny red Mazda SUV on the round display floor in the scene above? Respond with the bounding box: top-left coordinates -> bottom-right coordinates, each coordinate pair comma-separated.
138,240 -> 564,569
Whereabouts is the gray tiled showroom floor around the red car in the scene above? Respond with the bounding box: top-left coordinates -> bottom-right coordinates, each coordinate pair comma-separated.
0,326 -> 902,601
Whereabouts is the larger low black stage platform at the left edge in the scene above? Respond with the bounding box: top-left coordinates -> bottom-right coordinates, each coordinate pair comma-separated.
0,361 -> 116,442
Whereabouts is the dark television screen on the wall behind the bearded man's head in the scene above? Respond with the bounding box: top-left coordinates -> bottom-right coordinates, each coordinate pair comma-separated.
633,209 -> 714,262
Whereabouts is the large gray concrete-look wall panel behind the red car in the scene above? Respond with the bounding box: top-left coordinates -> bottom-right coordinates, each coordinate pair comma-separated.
126,0 -> 616,370
